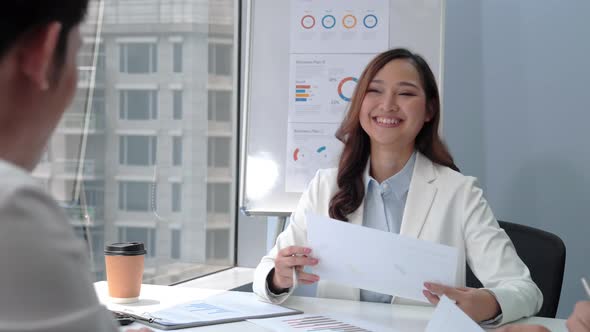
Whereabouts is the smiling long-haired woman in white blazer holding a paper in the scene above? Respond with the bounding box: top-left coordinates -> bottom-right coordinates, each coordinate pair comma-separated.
254,49 -> 543,325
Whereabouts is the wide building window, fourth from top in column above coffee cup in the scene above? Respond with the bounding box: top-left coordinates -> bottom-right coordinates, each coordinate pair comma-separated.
119,181 -> 158,212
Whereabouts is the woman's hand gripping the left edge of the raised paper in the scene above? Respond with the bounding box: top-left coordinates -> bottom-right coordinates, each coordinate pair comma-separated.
271,246 -> 320,289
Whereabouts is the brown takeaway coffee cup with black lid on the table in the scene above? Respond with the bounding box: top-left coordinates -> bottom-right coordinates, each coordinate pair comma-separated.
104,242 -> 146,303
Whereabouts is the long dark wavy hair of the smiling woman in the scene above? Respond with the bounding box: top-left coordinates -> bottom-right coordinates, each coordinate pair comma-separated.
329,48 -> 459,221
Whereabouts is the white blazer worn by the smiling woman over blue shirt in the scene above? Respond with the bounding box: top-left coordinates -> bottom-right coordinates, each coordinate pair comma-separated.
253,153 -> 543,324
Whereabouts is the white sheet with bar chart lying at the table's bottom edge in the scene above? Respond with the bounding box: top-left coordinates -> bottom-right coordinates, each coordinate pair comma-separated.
248,314 -> 397,332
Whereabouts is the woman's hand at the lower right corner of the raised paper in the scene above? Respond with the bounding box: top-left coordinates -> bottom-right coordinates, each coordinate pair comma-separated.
422,282 -> 501,323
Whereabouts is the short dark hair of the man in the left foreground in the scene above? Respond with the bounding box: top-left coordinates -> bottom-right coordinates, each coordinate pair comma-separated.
0,0 -> 89,65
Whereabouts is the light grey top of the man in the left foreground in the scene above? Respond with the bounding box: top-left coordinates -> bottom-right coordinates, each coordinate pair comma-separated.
0,159 -> 118,332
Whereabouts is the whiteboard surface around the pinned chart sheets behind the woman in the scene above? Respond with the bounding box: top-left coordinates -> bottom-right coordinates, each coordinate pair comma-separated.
239,0 -> 445,216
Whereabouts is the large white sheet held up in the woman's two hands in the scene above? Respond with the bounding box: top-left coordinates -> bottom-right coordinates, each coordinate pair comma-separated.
307,213 -> 459,302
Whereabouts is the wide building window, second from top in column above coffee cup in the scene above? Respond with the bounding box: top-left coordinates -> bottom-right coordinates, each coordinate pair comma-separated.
119,90 -> 158,120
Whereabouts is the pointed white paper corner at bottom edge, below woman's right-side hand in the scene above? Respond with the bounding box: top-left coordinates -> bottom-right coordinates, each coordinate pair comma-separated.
425,296 -> 484,332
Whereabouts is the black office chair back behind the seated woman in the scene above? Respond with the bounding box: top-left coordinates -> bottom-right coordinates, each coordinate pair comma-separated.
465,221 -> 565,318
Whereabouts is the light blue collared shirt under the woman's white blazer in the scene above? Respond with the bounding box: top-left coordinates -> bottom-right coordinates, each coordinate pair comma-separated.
361,152 -> 416,303
